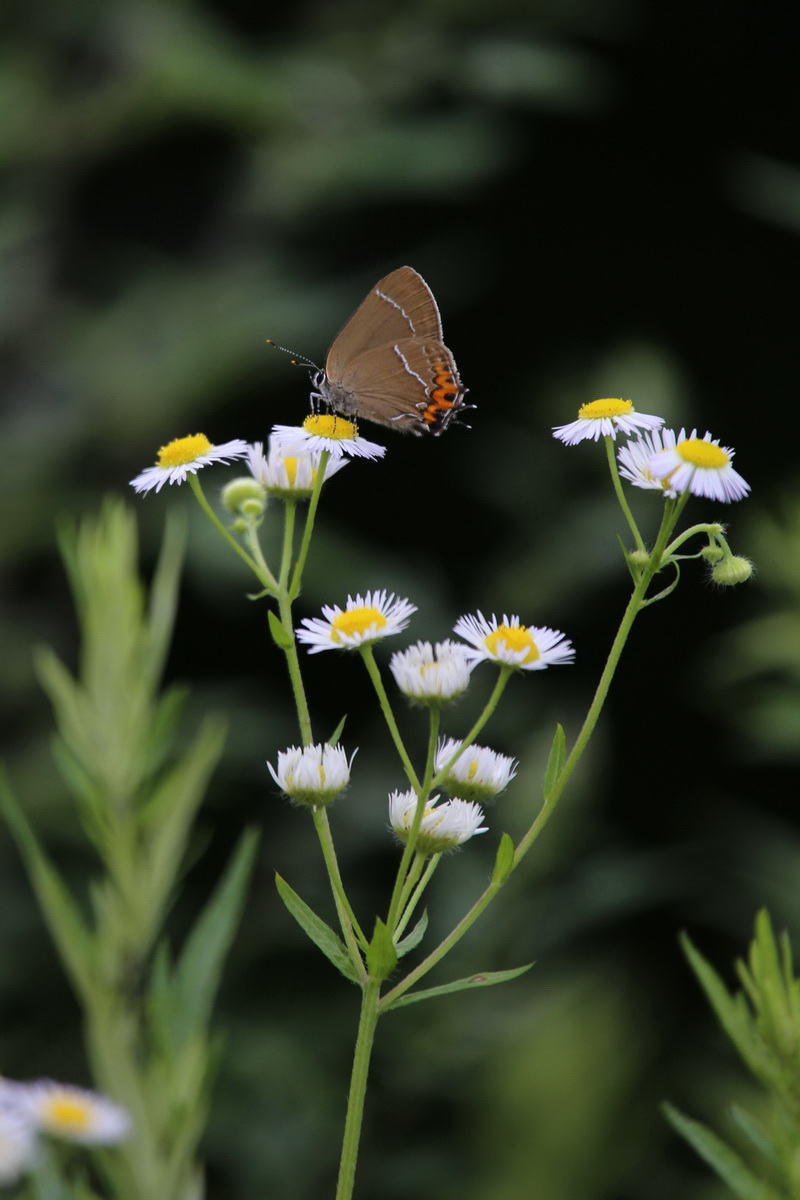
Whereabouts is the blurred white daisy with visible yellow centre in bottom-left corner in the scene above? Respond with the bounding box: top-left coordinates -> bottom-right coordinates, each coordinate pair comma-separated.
17,1079 -> 131,1146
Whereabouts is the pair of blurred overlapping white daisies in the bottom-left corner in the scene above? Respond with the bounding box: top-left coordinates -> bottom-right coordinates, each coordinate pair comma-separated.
0,1076 -> 131,1186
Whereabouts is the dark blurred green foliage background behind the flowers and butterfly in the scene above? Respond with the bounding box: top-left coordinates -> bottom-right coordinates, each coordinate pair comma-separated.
0,0 -> 800,1200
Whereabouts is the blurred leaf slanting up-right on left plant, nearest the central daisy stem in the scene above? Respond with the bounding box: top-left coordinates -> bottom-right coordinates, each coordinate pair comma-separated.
175,829 -> 258,1043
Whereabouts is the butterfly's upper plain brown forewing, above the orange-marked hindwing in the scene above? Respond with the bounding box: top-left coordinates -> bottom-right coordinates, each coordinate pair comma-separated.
325,266 -> 441,379
